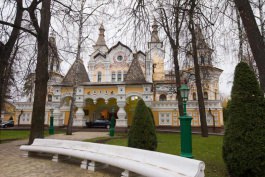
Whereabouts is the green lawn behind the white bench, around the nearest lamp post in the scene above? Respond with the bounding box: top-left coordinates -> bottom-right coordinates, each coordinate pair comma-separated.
89,133 -> 229,177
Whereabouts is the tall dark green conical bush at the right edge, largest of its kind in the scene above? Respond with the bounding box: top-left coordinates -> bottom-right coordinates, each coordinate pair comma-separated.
223,63 -> 265,177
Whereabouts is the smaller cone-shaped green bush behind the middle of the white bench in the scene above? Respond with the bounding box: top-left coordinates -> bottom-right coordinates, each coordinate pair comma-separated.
128,100 -> 157,151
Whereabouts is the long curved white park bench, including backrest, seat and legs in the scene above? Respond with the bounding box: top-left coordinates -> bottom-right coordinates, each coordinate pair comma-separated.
20,139 -> 205,177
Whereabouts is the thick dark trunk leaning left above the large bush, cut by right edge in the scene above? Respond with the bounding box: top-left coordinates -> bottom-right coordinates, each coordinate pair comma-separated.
234,0 -> 265,92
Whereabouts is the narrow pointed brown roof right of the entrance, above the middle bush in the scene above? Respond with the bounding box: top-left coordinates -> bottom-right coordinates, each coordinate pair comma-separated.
124,54 -> 146,83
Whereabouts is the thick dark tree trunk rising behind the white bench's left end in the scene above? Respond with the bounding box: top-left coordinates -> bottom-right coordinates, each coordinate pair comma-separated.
29,0 -> 51,144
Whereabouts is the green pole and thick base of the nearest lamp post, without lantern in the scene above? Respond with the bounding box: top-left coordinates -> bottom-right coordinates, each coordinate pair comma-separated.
179,101 -> 193,158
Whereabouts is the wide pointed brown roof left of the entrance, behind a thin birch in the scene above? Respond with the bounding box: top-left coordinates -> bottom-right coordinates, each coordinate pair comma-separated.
62,59 -> 90,85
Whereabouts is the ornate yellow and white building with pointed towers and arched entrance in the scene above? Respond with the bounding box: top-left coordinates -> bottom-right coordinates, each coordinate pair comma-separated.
8,23 -> 223,127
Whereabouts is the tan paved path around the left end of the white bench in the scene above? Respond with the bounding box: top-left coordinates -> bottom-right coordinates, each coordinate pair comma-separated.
0,132 -> 121,177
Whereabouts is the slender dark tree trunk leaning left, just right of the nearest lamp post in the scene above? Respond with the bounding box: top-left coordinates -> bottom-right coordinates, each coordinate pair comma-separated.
188,0 -> 208,137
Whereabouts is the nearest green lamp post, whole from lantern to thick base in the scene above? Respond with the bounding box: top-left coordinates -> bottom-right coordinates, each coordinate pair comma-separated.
179,84 -> 192,158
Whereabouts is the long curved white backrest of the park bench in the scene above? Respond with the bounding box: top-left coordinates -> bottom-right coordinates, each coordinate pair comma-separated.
32,139 -> 205,176
